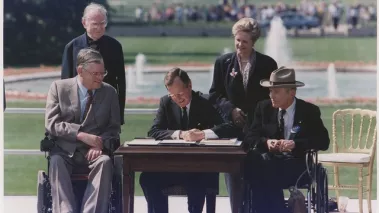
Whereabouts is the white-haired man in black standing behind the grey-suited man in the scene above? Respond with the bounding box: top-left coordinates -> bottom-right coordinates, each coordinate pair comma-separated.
61,3 -> 126,124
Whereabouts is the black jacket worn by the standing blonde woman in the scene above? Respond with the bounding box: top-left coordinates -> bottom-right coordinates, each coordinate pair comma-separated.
209,52 -> 278,126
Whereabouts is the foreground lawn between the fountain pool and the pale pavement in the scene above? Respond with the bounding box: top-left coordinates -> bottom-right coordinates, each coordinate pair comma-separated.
4,102 -> 376,198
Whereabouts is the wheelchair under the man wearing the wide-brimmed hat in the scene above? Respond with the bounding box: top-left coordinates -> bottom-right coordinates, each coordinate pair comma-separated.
244,150 -> 329,213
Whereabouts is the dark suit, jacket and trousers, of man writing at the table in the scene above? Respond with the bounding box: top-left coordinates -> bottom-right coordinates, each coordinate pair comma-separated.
140,92 -> 238,213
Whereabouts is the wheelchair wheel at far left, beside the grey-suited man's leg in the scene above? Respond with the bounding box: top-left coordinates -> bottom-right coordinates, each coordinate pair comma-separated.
37,170 -> 53,213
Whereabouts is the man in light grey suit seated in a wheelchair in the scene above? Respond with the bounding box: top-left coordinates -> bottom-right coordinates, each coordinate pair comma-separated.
45,48 -> 120,213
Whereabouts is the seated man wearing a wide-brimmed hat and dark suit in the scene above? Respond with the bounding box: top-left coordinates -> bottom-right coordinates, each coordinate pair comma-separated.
244,67 -> 330,213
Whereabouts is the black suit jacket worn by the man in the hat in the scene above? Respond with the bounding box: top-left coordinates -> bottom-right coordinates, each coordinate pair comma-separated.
244,99 -> 330,157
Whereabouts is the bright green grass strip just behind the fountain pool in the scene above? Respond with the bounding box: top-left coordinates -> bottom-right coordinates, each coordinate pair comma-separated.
117,37 -> 376,64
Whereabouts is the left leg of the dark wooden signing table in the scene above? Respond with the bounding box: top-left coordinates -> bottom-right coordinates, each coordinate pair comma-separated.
122,156 -> 134,213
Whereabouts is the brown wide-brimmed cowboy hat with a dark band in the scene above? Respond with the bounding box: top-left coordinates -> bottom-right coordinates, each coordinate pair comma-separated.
260,67 -> 304,87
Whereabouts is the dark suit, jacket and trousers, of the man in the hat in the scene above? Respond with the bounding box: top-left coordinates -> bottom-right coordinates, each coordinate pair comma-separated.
244,99 -> 330,213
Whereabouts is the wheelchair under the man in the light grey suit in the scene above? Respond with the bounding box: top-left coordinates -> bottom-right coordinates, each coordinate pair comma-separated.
37,133 -> 122,213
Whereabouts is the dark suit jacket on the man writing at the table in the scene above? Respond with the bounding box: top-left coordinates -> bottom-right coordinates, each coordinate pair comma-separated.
148,91 -> 239,140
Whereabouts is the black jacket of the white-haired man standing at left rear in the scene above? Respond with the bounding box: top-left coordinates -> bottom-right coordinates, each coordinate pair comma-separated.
61,33 -> 126,124
